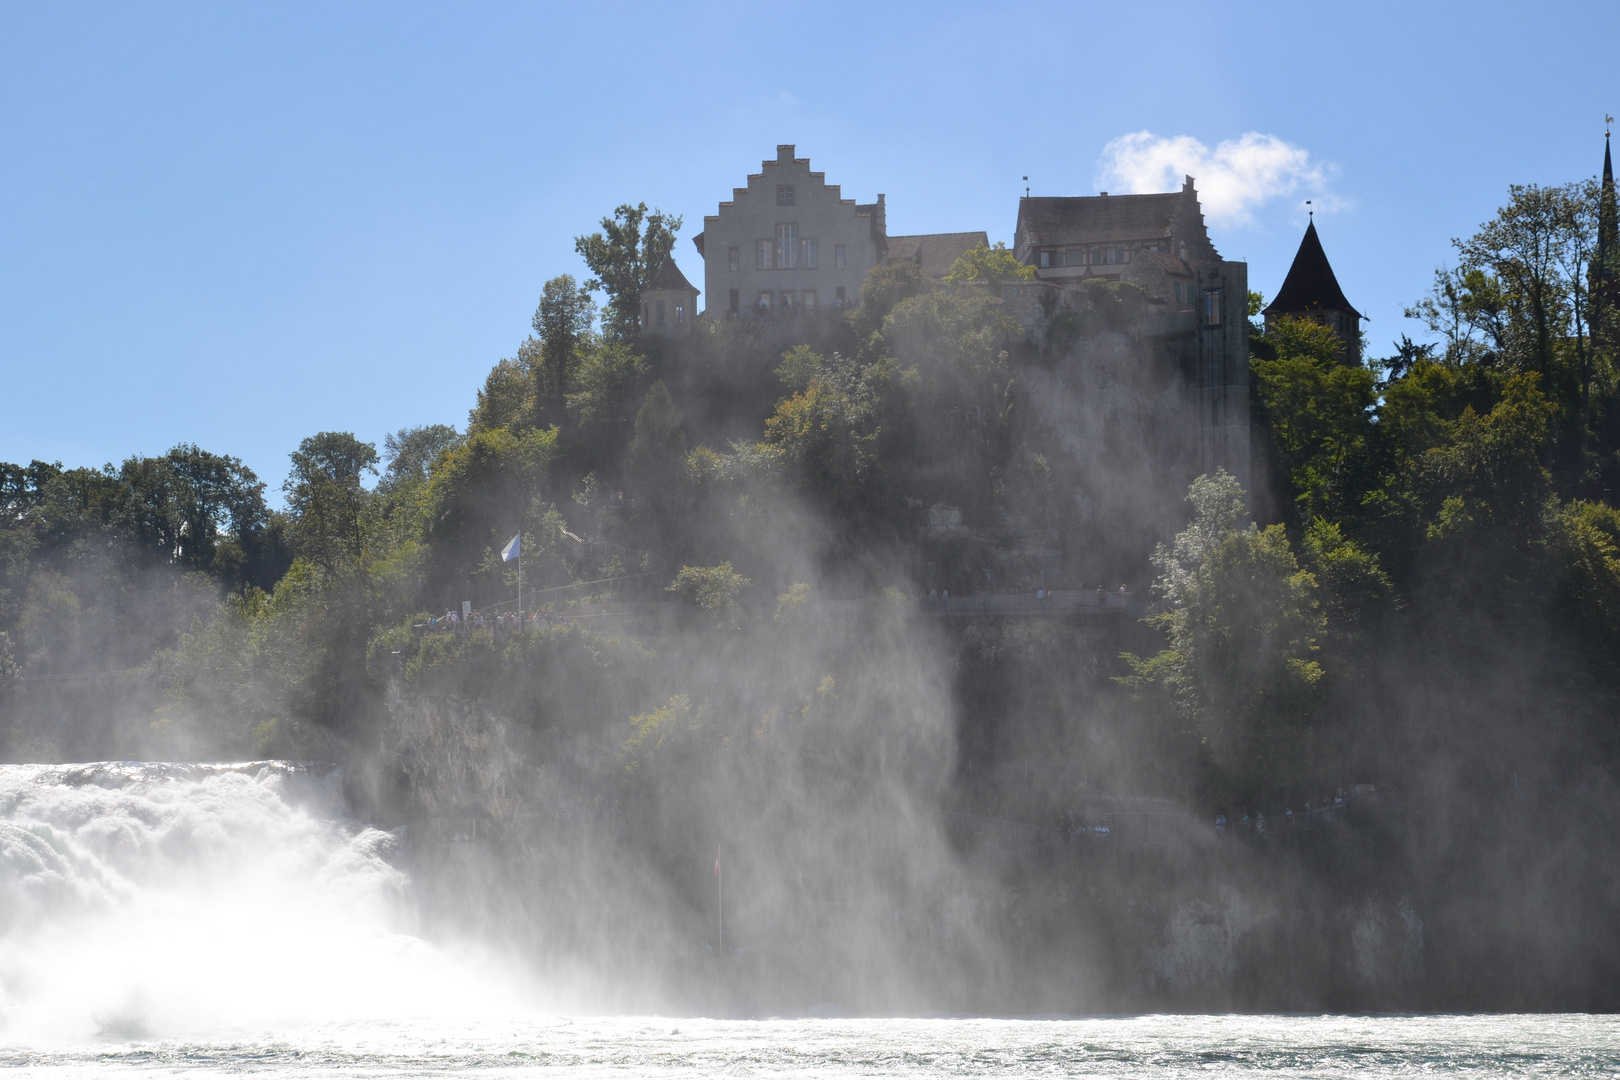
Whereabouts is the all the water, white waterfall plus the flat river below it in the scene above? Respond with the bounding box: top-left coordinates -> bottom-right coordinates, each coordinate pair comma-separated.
0,763 -> 1620,1077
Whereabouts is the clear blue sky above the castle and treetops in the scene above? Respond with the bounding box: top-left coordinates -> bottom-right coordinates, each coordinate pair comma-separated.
0,0 -> 1620,489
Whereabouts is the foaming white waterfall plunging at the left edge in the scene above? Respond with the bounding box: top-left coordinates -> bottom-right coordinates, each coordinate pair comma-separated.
0,761 -> 534,1046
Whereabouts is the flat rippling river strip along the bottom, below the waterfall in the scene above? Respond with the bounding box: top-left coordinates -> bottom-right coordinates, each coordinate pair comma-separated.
0,1015 -> 1620,1080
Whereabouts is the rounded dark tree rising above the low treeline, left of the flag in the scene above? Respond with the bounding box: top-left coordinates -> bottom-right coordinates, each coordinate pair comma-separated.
282,431 -> 377,572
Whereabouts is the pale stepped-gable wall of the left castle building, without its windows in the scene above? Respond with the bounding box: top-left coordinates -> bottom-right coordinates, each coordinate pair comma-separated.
703,146 -> 883,319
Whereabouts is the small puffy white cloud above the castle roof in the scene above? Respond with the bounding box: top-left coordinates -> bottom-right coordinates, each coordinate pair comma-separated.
1097,131 -> 1340,227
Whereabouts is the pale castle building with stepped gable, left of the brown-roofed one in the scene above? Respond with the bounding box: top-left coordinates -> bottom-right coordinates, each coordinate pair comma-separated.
692,144 -> 888,319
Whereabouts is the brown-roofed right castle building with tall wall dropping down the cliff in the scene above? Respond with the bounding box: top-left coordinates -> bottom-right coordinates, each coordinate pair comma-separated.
1003,176 -> 1251,487
